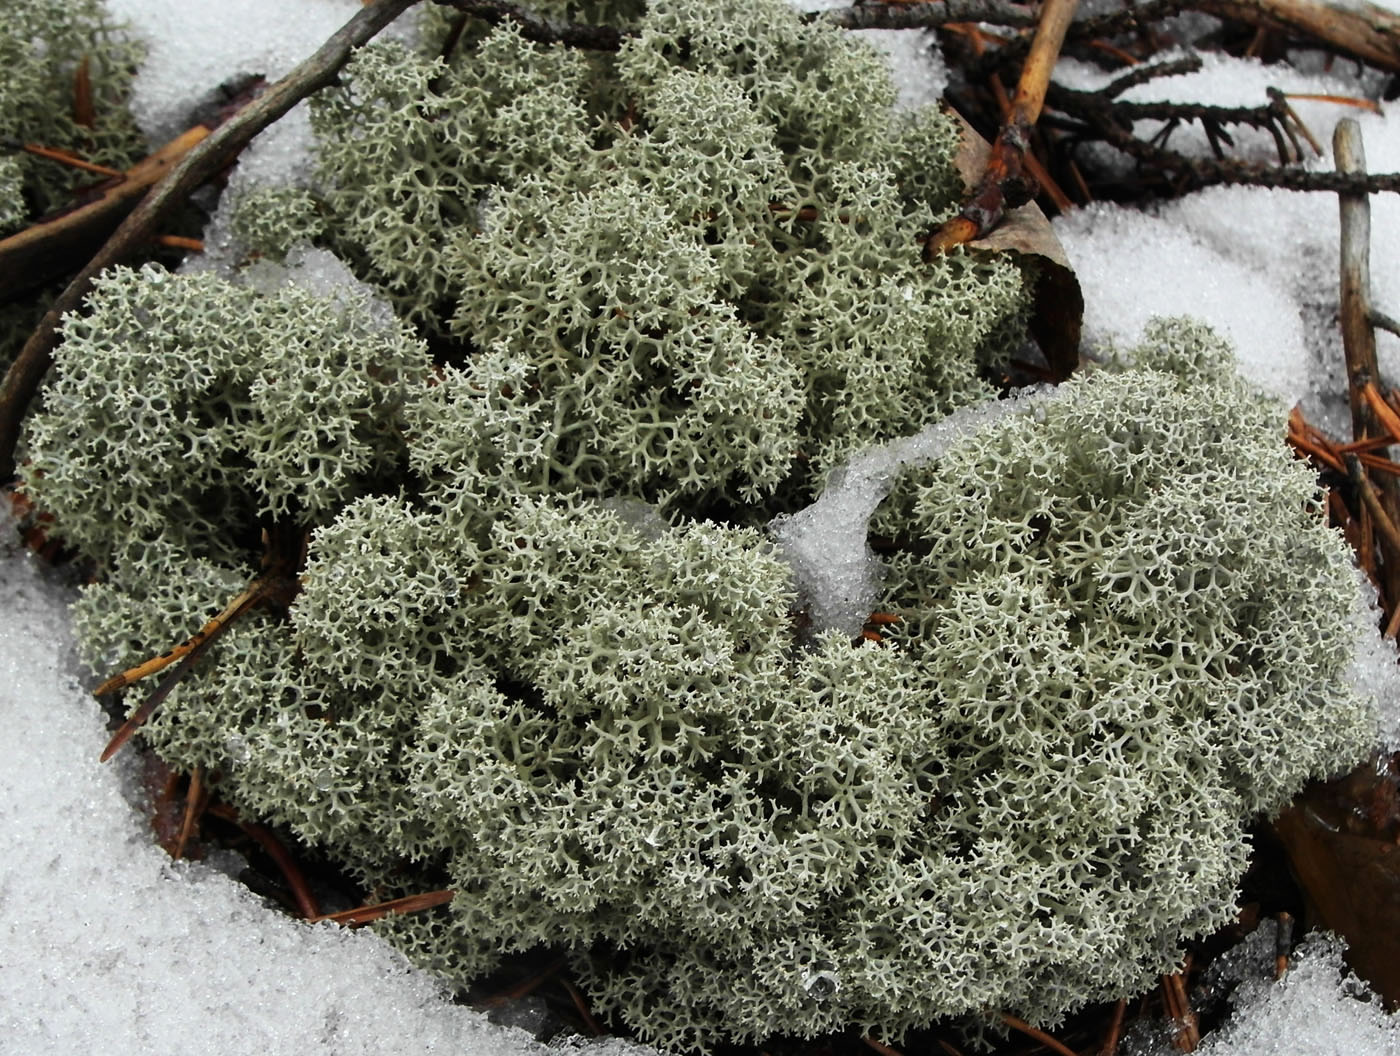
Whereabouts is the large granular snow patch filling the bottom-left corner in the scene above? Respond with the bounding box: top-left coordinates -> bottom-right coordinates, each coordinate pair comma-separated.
0,524 -> 645,1056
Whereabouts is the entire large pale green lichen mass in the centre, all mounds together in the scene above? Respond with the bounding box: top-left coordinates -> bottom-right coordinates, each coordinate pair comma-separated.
16,3 -> 1371,1050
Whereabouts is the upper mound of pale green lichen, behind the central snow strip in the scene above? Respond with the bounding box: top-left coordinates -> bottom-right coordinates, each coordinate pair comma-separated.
239,0 -> 1025,498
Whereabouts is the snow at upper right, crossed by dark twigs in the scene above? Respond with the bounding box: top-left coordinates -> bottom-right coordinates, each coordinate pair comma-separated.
1054,55 -> 1400,422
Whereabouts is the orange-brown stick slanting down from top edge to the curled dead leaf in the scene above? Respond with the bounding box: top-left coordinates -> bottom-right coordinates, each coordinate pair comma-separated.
924,0 -> 1079,250
